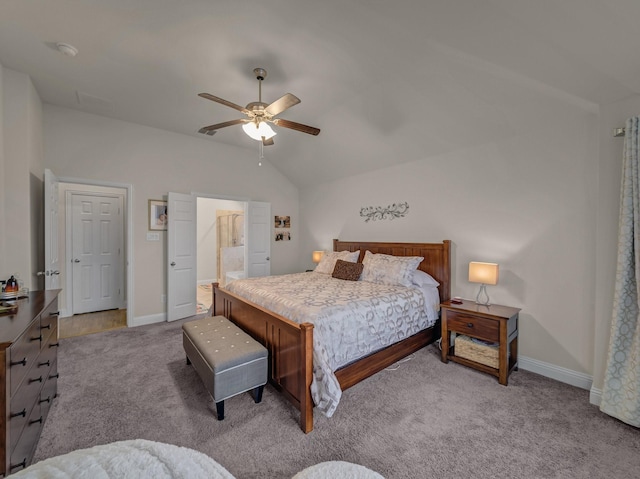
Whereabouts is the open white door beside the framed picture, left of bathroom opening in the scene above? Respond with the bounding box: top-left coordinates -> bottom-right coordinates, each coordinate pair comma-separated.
167,193 -> 198,321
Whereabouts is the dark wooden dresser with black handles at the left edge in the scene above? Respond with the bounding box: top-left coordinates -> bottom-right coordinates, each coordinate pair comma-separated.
0,290 -> 60,476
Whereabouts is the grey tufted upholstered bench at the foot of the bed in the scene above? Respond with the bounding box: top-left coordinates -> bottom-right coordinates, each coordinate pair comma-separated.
182,316 -> 268,420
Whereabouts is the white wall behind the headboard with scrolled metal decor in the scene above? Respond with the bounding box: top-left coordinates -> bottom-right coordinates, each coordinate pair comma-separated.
300,84 -> 598,387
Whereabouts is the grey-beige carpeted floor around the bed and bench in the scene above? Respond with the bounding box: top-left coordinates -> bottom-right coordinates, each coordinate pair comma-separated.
35,320 -> 640,479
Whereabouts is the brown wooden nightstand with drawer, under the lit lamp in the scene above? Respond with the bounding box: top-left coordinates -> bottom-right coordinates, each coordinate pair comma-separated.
440,300 -> 520,386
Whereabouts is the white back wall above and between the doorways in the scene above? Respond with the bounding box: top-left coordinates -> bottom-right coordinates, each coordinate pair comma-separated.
44,104 -> 298,321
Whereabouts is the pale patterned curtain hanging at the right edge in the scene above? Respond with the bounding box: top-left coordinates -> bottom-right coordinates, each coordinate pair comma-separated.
600,117 -> 640,427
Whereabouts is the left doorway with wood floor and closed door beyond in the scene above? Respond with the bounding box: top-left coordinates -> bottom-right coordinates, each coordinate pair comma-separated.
57,178 -> 131,337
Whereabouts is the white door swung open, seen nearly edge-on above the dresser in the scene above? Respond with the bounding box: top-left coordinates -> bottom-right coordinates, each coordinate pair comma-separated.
43,169 -> 60,289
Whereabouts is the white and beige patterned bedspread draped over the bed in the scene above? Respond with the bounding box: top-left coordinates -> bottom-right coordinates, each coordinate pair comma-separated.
225,272 -> 437,417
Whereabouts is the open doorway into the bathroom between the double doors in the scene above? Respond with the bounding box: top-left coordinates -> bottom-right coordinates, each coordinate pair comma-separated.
196,197 -> 247,314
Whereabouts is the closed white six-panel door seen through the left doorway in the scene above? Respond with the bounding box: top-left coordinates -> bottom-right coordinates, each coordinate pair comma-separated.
71,193 -> 124,314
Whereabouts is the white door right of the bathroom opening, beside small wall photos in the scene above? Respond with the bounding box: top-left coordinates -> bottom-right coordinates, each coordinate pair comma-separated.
246,201 -> 272,278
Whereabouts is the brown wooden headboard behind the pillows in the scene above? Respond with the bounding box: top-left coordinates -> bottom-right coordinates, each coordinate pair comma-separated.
333,239 -> 451,301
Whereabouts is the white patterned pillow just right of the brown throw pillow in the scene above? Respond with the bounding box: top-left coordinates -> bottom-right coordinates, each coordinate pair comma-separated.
360,251 -> 424,287
